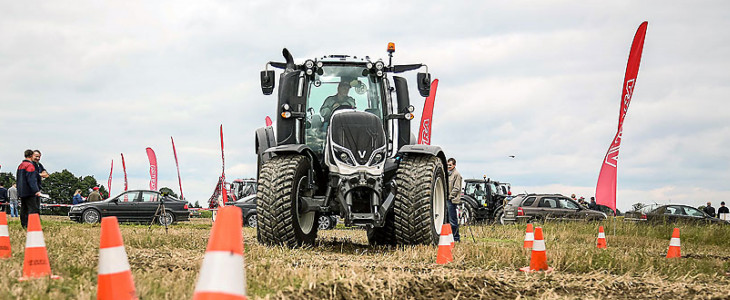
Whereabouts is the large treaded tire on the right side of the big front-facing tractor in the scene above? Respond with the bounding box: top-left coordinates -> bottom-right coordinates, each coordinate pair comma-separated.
386,155 -> 449,245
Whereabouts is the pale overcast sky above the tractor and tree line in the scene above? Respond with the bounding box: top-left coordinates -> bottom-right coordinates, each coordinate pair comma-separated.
0,0 -> 730,210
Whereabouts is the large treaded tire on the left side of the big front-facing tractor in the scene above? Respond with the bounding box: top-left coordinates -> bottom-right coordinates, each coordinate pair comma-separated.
256,154 -> 317,248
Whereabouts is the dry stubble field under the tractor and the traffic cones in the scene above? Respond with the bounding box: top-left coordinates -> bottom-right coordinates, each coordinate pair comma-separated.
0,216 -> 730,299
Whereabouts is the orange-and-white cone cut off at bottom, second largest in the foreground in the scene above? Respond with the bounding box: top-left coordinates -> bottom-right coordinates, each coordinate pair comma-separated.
96,217 -> 137,300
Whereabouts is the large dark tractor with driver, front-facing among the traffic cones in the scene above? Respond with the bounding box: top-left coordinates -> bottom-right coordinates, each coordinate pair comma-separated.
255,43 -> 448,248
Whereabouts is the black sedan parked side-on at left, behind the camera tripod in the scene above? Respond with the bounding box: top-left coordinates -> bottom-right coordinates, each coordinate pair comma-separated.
68,190 -> 190,225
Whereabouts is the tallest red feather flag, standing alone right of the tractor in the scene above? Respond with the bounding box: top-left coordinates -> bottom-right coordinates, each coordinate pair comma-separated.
596,22 -> 648,213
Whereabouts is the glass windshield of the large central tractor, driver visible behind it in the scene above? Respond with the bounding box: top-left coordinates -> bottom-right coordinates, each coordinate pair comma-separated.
306,65 -> 383,153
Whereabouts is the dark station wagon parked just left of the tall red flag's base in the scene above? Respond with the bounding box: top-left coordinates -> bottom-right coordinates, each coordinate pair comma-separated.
500,194 -> 606,224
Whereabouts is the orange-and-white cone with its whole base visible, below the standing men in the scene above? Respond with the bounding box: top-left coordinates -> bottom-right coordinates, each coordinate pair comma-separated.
19,214 -> 61,281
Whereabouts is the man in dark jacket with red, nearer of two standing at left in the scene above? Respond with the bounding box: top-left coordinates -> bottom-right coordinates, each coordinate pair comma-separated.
15,149 -> 41,228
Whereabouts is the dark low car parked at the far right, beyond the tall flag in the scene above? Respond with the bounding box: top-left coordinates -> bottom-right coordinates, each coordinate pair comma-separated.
624,204 -> 730,224
